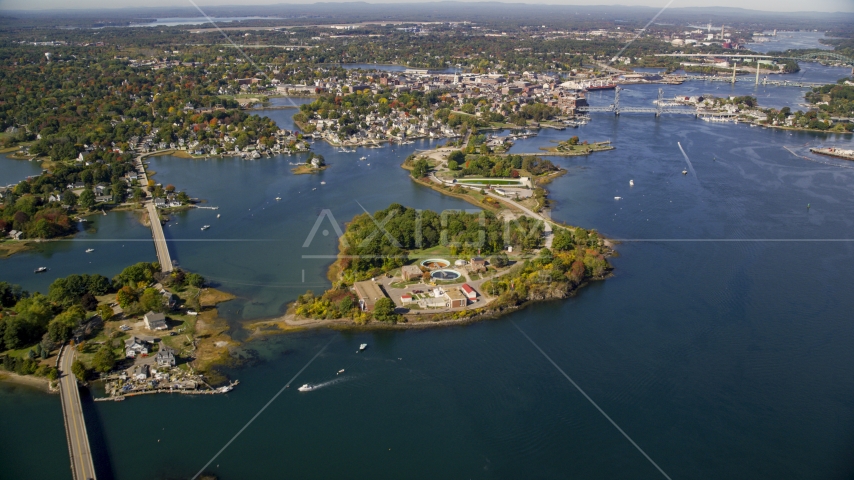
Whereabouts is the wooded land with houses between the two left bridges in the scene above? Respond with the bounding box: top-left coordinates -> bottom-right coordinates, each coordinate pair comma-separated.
0,262 -> 239,391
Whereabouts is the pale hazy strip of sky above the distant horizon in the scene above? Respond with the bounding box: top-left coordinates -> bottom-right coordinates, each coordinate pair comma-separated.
0,0 -> 854,13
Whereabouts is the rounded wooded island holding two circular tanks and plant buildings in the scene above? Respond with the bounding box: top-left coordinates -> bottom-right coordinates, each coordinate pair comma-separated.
284,196 -> 613,328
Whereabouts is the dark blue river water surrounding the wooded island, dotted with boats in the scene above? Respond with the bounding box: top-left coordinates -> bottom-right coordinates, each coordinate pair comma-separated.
0,78 -> 854,480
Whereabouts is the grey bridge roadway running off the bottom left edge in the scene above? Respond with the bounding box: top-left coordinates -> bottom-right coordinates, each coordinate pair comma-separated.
59,347 -> 95,480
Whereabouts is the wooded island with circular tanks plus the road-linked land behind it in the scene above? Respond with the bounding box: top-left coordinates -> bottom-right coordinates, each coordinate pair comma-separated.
254,137 -> 616,336
